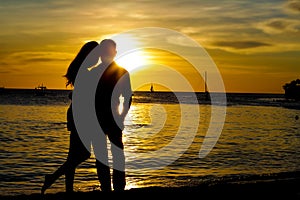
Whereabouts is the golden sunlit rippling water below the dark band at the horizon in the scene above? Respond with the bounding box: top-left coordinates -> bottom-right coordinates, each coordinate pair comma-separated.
0,103 -> 300,194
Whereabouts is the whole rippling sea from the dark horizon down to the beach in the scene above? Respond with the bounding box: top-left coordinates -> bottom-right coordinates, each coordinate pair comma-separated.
0,90 -> 300,195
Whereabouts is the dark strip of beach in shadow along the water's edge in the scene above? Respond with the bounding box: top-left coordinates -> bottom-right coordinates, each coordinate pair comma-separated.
0,177 -> 300,200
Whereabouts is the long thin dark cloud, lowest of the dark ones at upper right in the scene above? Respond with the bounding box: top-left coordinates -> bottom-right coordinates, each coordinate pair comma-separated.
214,41 -> 272,49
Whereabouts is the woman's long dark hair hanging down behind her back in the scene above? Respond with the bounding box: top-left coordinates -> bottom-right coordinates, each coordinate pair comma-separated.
64,41 -> 99,87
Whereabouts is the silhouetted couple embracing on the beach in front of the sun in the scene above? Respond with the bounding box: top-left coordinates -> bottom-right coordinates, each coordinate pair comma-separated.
41,39 -> 132,194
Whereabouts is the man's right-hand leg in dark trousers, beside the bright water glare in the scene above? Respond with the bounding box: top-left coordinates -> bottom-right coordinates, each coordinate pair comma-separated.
108,129 -> 126,191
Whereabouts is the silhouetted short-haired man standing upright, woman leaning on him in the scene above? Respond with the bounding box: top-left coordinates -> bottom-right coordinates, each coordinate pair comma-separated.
94,39 -> 132,191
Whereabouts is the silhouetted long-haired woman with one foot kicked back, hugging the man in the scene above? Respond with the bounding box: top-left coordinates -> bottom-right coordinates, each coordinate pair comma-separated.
41,41 -> 99,194
